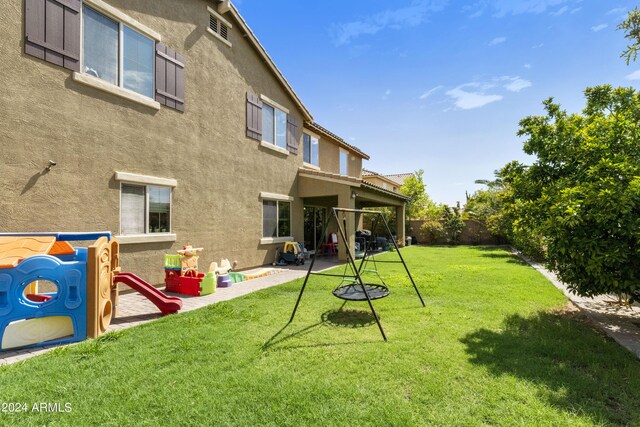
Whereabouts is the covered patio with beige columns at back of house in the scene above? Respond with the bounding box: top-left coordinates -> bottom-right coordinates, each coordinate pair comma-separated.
298,168 -> 408,260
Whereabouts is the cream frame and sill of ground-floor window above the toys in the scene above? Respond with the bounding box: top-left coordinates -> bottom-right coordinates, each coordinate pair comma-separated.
114,172 -> 178,244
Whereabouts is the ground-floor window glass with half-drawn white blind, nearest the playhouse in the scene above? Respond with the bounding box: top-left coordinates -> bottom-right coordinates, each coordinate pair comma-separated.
120,183 -> 171,235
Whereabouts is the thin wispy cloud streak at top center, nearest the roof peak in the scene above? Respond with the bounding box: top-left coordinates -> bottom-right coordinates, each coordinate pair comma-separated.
331,0 -> 448,46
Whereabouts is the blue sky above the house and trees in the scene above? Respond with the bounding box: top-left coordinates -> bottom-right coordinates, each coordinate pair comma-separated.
234,0 -> 640,204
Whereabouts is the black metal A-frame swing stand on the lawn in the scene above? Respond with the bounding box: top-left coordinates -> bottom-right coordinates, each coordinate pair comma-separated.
289,208 -> 426,341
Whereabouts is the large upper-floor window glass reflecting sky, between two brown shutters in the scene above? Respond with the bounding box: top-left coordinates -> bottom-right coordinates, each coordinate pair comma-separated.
82,5 -> 155,98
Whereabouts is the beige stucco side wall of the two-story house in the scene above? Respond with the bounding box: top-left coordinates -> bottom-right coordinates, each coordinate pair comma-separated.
0,0 -> 310,283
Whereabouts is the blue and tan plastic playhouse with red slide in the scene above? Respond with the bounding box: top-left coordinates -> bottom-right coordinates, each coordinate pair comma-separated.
0,232 -> 182,351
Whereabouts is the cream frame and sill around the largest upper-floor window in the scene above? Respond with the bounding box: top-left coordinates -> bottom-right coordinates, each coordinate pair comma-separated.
73,0 -> 162,110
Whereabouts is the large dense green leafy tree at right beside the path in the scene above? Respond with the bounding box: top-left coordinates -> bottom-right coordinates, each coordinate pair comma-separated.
502,85 -> 640,296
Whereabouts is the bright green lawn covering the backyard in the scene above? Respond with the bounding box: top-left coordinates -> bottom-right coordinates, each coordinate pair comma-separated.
0,247 -> 640,426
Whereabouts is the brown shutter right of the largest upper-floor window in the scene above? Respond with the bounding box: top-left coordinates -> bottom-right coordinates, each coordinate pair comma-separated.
156,43 -> 185,111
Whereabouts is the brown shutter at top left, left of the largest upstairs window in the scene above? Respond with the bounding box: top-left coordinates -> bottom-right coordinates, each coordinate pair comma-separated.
24,0 -> 82,71
